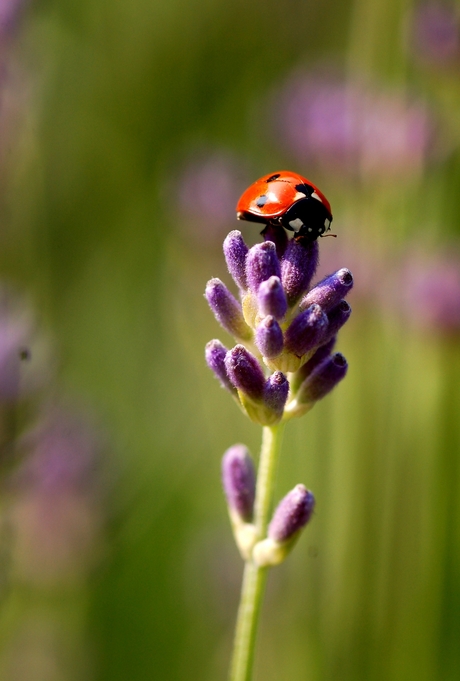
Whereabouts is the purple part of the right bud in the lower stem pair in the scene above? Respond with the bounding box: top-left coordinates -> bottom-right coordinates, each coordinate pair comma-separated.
268,485 -> 315,543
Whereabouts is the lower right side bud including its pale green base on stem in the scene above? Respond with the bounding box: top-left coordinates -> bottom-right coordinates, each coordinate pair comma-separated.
252,485 -> 315,567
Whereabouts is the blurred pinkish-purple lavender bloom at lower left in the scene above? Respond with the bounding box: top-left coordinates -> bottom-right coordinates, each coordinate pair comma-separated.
10,407 -> 104,586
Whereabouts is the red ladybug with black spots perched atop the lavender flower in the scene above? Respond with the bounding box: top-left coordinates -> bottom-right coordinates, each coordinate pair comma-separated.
236,170 -> 332,243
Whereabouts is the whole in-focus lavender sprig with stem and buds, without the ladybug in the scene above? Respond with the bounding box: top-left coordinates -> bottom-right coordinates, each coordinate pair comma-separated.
205,227 -> 353,681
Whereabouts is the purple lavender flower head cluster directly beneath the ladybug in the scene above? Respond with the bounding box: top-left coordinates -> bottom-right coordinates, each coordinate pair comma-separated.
205,227 -> 353,426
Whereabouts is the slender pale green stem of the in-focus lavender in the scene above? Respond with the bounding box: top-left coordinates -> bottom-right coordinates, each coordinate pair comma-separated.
229,424 -> 284,681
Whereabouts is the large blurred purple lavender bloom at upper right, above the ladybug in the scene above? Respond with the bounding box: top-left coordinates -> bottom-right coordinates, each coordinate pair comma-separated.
274,73 -> 434,182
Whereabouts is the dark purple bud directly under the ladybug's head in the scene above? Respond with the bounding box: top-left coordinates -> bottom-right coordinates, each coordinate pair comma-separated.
281,239 -> 319,302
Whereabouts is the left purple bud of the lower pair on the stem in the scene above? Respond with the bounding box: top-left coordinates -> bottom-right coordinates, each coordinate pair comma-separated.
222,445 -> 256,522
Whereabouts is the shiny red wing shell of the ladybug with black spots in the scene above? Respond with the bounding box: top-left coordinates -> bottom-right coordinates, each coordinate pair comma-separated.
236,170 -> 332,222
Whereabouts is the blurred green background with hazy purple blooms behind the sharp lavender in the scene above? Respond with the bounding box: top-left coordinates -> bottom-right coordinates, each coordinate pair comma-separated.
0,0 -> 460,681
